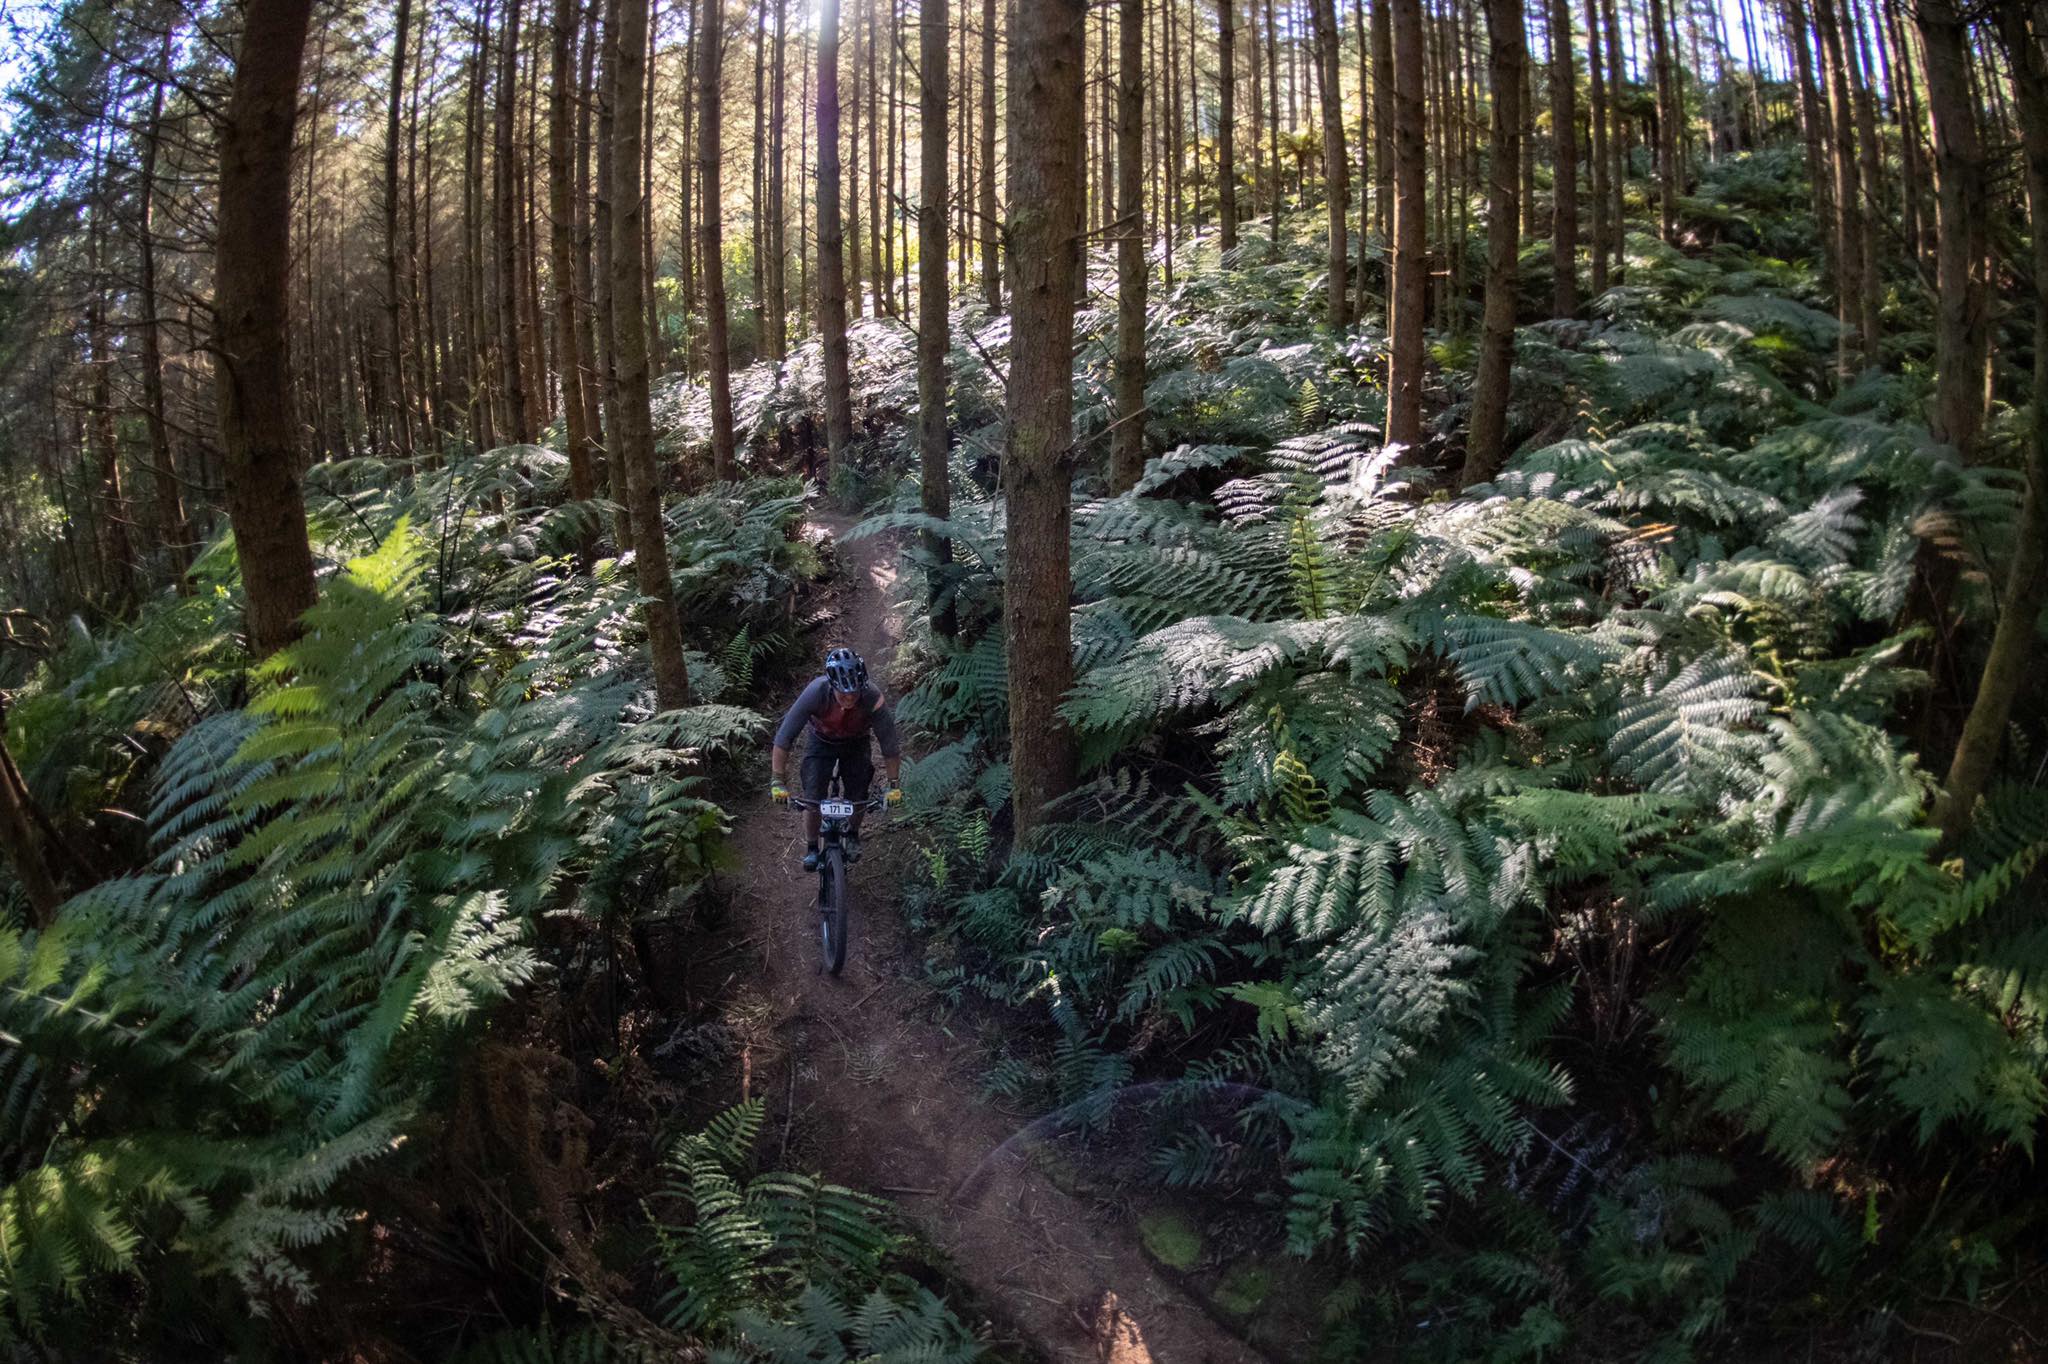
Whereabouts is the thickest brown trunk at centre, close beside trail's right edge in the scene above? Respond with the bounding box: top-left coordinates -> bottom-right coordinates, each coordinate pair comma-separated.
1007,0 -> 1087,840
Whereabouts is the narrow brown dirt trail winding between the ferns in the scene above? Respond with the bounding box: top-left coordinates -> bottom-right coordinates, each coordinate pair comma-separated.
735,520 -> 1266,1364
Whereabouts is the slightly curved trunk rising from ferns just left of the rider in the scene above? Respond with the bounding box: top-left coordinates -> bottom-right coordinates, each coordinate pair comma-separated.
606,0 -> 690,711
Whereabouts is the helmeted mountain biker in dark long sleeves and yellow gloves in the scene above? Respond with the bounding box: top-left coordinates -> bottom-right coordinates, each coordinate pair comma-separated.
768,649 -> 903,870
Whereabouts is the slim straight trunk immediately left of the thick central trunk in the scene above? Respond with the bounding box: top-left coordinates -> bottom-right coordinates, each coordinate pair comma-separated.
918,0 -> 954,639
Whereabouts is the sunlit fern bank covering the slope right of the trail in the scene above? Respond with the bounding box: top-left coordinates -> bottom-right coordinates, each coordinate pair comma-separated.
868,146 -> 2048,1360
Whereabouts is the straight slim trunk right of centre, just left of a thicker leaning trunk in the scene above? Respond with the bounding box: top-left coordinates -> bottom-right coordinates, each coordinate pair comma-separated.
1386,0 -> 1425,446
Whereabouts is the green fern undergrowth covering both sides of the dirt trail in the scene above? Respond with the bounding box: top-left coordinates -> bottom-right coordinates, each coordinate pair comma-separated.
0,143 -> 2048,1360
